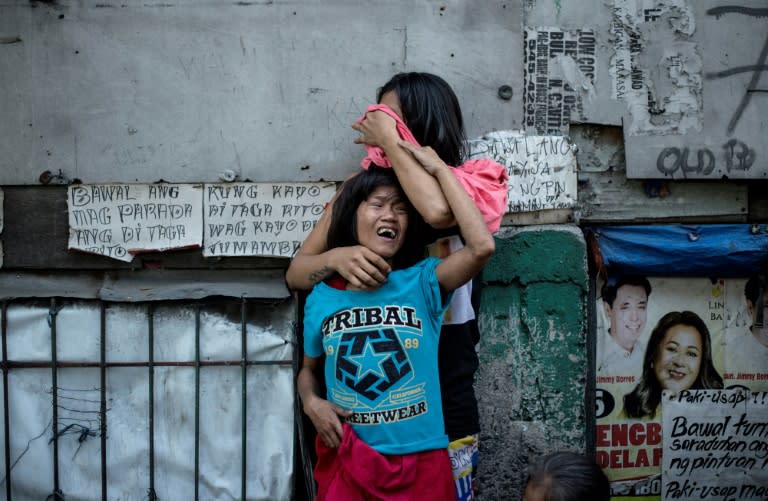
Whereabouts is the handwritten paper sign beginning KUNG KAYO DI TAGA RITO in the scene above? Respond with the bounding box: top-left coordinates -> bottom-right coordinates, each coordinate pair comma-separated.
203,183 -> 336,257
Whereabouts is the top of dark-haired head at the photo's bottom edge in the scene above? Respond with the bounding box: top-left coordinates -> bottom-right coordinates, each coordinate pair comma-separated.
527,451 -> 611,501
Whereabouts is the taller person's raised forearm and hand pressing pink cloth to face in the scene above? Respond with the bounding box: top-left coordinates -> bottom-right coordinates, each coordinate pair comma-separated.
352,111 -> 456,228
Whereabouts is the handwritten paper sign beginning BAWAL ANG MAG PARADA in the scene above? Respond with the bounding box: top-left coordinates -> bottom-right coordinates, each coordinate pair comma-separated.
67,184 -> 203,262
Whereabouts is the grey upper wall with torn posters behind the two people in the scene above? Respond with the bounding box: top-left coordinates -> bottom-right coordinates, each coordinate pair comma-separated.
0,0 -> 768,184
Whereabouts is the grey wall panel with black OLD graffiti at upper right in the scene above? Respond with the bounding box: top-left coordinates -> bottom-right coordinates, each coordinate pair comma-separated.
624,0 -> 768,179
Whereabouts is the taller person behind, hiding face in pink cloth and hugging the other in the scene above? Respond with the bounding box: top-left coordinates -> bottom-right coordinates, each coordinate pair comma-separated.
286,72 -> 507,501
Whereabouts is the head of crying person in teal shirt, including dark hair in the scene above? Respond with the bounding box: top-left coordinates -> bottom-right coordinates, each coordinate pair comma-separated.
327,166 -> 424,268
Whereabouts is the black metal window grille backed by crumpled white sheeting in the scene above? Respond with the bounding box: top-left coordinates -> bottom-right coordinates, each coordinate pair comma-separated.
0,298 -> 295,501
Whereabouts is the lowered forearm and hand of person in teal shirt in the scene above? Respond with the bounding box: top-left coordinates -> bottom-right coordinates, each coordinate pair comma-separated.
296,355 -> 352,447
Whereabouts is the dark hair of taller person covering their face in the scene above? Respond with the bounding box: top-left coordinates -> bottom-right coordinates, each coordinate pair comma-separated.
376,72 -> 466,167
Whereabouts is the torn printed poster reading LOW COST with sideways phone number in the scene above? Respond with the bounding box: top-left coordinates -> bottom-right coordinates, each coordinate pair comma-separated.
523,28 -> 596,135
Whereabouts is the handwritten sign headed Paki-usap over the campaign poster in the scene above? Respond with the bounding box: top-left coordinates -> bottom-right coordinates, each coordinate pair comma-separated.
661,389 -> 768,500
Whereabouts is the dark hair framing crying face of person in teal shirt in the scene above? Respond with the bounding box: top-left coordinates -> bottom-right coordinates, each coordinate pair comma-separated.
326,165 -> 425,269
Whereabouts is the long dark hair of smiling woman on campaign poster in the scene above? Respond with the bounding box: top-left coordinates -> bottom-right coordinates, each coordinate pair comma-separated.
624,311 -> 723,418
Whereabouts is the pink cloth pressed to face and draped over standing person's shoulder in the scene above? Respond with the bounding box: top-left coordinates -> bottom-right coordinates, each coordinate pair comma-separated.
355,104 -> 509,233
